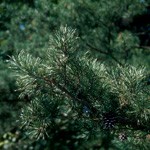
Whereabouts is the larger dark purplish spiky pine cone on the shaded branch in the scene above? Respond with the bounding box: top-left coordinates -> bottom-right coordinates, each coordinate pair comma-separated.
103,112 -> 116,129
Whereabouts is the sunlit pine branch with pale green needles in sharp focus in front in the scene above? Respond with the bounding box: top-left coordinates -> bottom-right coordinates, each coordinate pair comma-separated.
11,26 -> 150,149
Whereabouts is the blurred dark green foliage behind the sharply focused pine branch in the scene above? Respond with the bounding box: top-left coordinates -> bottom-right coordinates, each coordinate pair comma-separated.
0,0 -> 150,149
